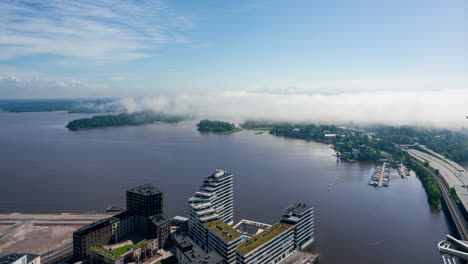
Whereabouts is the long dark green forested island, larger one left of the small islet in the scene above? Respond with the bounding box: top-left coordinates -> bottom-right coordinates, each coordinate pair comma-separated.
66,112 -> 184,131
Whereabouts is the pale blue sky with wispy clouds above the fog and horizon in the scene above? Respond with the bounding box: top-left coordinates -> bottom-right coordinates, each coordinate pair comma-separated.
0,0 -> 468,98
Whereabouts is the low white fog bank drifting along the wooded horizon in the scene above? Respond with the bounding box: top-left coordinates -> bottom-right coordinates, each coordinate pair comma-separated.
90,89 -> 468,130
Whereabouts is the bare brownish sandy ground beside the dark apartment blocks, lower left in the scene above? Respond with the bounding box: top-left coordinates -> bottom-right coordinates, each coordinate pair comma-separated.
0,212 -> 116,255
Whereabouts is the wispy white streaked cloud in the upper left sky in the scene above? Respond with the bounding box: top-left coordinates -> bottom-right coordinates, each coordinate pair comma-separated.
0,0 -> 193,63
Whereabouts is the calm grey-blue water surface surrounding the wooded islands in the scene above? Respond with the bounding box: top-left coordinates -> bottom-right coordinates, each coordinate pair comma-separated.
0,113 -> 450,264
